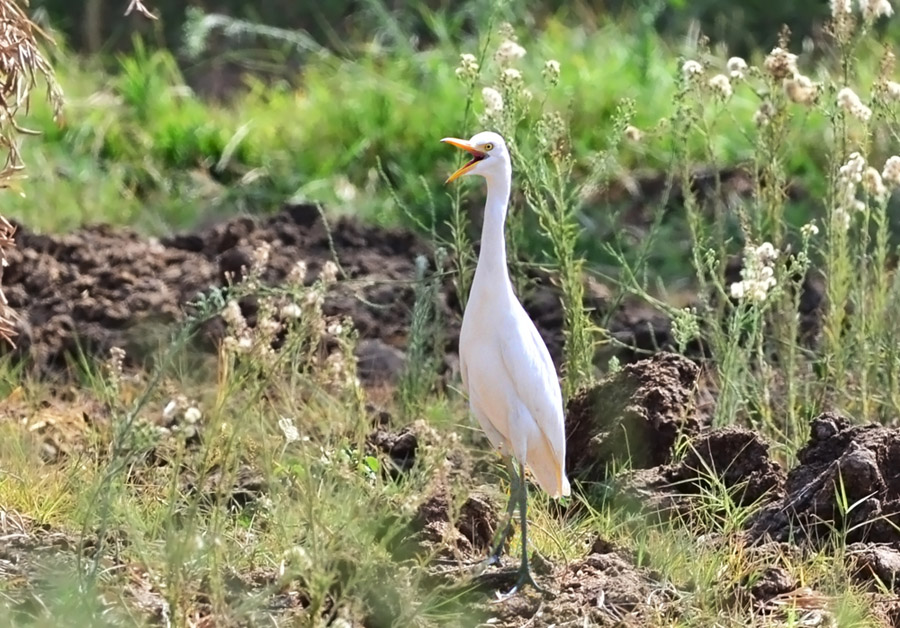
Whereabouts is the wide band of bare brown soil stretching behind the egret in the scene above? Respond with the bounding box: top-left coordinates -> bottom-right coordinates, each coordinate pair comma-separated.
0,204 -> 684,385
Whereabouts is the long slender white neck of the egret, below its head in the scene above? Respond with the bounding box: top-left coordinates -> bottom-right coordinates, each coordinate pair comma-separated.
473,170 -> 512,290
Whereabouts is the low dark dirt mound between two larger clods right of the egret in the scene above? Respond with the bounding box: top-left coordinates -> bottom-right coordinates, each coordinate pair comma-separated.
663,427 -> 784,505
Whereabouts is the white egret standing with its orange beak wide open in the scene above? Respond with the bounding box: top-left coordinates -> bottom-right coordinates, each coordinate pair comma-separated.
441,131 -> 570,595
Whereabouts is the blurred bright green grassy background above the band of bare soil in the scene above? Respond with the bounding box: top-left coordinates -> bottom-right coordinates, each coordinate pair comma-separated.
6,0 -> 888,275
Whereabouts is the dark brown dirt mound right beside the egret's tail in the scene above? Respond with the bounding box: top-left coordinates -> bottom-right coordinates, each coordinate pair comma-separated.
566,353 -> 700,481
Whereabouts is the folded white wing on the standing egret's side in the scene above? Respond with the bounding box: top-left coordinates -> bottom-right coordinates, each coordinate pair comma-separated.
500,317 -> 566,460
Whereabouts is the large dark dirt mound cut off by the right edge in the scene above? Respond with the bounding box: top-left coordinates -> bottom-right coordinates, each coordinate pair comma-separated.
749,413 -> 900,543
